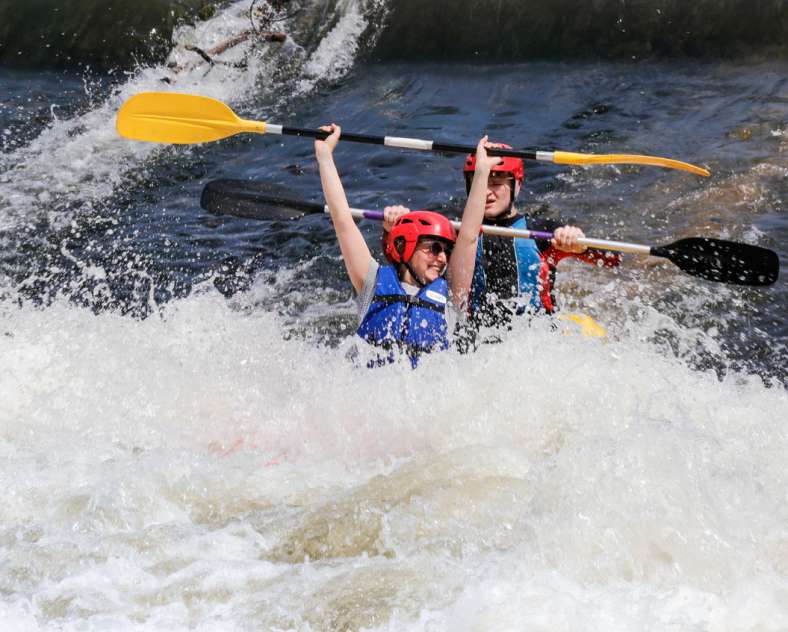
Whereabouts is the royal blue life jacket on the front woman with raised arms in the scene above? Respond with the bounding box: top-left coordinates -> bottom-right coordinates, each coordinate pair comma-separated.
357,266 -> 449,368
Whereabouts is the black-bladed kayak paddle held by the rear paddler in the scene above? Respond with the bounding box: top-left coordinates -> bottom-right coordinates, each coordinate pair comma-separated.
200,179 -> 780,286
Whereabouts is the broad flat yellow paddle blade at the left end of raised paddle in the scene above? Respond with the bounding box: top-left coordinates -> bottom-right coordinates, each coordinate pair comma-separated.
116,92 -> 265,144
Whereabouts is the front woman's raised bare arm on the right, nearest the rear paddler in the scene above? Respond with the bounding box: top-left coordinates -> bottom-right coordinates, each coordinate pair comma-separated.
447,136 -> 501,311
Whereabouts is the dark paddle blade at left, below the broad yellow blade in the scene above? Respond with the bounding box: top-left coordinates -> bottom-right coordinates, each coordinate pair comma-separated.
200,178 -> 323,220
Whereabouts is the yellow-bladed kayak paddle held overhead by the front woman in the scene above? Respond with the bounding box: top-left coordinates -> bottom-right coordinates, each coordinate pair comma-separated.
117,92 -> 709,176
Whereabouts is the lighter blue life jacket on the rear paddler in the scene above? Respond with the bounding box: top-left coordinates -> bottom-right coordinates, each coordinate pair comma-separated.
469,217 -> 544,314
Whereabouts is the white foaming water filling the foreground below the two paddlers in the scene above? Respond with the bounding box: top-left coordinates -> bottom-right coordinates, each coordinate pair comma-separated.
0,282 -> 788,630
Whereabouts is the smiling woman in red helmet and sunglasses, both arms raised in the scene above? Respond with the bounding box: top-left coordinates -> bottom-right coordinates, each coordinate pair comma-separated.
315,125 -> 500,368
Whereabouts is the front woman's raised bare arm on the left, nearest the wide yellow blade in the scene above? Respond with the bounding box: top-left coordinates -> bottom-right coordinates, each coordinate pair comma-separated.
315,124 -> 372,293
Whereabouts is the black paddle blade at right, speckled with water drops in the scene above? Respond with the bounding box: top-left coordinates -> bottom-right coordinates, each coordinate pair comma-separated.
651,237 -> 780,286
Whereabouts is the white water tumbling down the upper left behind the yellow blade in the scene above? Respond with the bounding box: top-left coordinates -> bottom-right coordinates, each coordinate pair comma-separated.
0,0 -> 366,230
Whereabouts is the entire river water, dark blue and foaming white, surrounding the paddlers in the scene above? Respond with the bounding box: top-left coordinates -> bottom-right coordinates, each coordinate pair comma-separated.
0,0 -> 788,632
